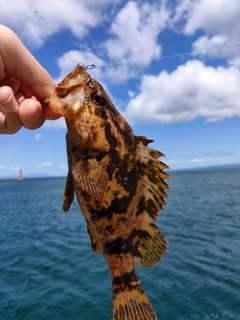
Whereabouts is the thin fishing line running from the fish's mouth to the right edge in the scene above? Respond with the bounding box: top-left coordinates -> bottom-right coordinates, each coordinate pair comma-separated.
89,47 -> 240,69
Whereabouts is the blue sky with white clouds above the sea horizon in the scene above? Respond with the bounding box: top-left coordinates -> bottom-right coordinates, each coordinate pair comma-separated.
0,0 -> 240,177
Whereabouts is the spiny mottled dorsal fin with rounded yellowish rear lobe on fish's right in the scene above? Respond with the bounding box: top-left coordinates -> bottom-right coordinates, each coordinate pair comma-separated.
135,137 -> 170,268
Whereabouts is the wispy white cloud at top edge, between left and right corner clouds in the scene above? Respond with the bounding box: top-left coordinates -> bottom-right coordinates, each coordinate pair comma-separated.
103,1 -> 169,65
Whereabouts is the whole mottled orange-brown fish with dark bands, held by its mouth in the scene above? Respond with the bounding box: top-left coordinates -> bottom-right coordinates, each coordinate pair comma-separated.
44,64 -> 170,320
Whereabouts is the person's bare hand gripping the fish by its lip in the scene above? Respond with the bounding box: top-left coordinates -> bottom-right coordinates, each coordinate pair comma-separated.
0,25 -> 60,134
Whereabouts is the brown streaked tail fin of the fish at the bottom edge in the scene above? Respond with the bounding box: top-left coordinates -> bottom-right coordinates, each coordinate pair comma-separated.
113,275 -> 157,320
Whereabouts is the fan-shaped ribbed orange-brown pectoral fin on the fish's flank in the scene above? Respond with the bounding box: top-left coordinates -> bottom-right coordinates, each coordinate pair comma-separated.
72,159 -> 109,204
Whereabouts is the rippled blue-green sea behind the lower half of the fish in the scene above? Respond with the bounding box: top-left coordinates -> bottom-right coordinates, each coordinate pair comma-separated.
0,169 -> 240,320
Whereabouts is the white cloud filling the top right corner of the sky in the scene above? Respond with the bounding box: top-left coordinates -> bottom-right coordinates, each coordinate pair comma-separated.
172,0 -> 240,57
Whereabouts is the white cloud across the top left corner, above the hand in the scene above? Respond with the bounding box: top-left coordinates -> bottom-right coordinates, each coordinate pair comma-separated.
0,0 -> 112,46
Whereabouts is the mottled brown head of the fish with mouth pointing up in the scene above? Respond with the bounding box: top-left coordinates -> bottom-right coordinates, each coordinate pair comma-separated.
44,64 -> 135,152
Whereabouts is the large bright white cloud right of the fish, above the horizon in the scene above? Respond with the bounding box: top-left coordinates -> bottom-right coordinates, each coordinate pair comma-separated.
124,60 -> 240,124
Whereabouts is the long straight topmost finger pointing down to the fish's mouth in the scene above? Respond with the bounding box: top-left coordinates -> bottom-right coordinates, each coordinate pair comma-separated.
0,25 -> 55,99
